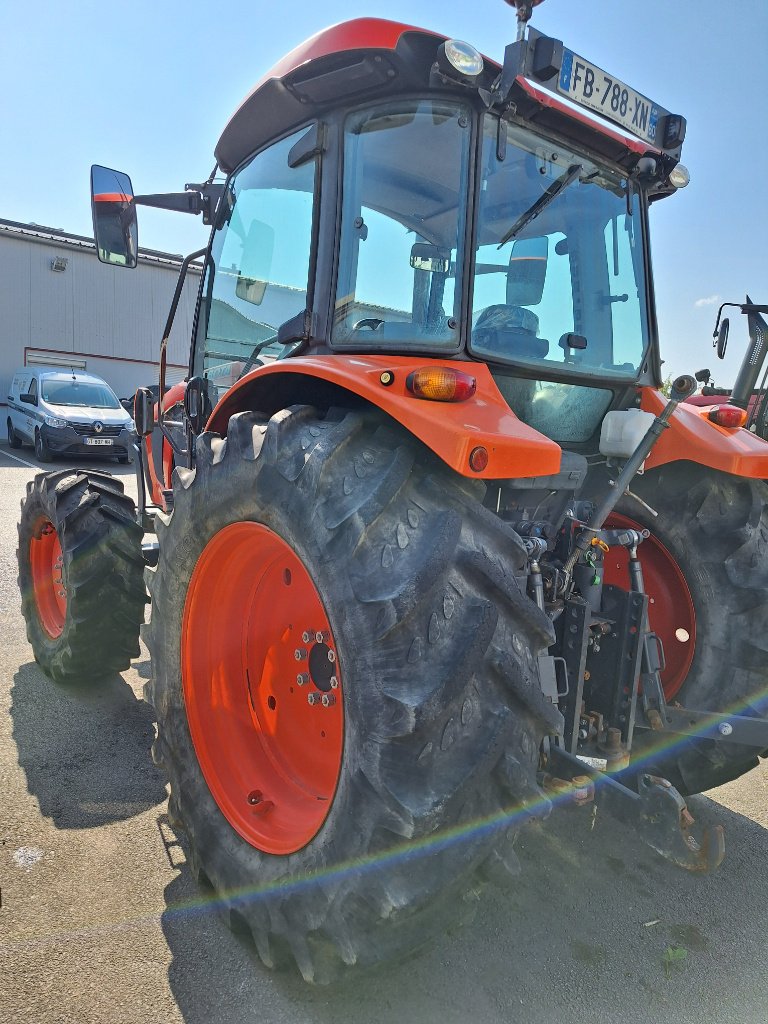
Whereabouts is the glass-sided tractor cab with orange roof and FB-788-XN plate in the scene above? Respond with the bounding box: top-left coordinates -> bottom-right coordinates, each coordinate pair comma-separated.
193,18 -> 687,443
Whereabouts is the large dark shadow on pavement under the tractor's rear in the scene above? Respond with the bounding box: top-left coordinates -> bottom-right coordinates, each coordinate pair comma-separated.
157,778 -> 768,1024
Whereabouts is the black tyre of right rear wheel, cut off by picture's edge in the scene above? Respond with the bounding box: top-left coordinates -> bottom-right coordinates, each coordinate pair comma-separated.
617,463 -> 768,794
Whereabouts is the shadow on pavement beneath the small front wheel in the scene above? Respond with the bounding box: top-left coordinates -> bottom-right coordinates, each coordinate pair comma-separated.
10,663 -> 166,828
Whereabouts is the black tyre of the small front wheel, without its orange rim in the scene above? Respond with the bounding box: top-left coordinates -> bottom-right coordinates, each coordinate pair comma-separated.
17,469 -> 147,683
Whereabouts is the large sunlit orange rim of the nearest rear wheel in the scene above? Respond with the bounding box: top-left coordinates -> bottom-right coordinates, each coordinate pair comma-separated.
181,522 -> 344,854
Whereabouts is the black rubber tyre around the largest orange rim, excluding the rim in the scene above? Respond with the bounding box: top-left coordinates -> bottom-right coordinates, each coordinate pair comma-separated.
146,407 -> 561,983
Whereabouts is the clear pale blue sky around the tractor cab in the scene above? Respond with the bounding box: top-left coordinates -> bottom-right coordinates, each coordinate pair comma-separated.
0,0 -> 768,384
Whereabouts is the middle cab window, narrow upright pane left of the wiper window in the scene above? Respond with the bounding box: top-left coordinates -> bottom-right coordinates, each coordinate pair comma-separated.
333,99 -> 472,351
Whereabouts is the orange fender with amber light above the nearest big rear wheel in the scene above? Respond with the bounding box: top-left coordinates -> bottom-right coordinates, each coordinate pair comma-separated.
207,355 -> 561,479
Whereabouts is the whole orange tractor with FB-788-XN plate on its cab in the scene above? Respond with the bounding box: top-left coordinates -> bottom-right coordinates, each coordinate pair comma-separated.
19,2 -> 768,982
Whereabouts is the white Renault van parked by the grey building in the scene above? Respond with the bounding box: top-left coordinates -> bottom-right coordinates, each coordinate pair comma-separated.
7,367 -> 135,463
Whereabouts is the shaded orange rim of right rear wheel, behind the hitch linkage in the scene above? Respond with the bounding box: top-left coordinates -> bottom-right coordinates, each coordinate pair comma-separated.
605,513 -> 696,700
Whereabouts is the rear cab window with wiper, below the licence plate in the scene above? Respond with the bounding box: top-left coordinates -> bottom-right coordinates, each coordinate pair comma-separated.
470,117 -> 648,379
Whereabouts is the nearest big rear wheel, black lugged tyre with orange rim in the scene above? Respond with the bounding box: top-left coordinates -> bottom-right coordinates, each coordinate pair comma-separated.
146,407 -> 561,984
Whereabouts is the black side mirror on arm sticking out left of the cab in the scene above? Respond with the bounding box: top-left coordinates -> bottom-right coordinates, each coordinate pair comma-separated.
91,164 -> 138,267
